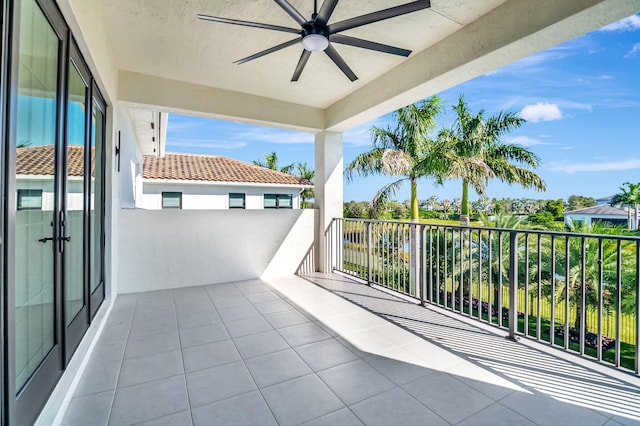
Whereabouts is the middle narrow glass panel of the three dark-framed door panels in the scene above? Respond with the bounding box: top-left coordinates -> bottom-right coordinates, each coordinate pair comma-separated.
63,61 -> 88,327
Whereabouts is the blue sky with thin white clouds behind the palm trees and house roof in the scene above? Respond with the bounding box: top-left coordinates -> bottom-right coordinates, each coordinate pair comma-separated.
167,14 -> 640,201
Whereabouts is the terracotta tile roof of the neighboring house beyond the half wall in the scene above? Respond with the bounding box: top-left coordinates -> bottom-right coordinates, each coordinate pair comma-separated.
143,154 -> 313,186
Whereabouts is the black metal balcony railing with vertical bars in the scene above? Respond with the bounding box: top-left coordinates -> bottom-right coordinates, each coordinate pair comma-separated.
325,219 -> 640,374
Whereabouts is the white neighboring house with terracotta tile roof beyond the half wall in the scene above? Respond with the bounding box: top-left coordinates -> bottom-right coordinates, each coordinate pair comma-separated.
136,154 -> 313,210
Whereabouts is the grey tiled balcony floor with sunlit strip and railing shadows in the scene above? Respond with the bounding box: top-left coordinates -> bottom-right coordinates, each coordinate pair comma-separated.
62,274 -> 640,426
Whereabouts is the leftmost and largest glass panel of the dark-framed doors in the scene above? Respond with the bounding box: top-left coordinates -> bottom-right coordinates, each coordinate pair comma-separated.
15,0 -> 60,392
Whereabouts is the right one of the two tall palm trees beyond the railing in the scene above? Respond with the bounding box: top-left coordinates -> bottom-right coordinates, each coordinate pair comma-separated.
439,95 -> 546,225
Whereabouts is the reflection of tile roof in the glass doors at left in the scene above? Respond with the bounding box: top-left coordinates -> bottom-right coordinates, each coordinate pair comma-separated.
16,145 -> 93,176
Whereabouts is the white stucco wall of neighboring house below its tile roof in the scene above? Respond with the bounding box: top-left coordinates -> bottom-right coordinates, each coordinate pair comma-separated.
136,181 -> 300,210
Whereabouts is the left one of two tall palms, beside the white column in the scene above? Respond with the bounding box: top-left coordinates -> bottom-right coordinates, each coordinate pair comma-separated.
345,96 -> 442,221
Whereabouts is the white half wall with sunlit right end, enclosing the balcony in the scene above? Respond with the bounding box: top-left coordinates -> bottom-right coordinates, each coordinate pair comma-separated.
117,209 -> 315,293
